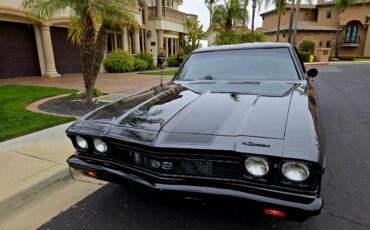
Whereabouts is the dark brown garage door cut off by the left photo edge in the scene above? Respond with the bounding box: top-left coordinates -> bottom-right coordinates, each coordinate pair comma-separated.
0,21 -> 41,78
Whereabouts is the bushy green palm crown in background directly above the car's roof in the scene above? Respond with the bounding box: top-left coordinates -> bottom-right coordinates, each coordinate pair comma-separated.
212,0 -> 245,31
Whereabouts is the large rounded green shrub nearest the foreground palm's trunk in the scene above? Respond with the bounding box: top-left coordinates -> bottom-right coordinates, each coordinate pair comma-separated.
104,50 -> 135,73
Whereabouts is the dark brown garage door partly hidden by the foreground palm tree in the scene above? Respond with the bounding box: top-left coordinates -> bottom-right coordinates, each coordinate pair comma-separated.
50,27 -> 81,74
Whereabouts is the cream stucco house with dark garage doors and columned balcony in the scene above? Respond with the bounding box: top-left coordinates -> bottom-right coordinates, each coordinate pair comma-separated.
0,0 -> 197,79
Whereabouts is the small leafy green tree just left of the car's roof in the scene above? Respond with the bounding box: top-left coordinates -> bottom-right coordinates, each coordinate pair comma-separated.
186,18 -> 205,51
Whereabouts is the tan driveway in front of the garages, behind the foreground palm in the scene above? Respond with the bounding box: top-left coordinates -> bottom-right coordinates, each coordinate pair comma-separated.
0,72 -> 172,94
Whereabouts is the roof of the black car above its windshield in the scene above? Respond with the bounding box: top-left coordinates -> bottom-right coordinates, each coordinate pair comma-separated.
193,42 -> 292,53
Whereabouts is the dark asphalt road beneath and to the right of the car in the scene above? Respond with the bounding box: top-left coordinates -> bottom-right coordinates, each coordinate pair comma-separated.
40,64 -> 370,230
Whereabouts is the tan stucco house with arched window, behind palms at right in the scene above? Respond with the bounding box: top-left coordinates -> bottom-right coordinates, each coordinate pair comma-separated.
261,0 -> 370,57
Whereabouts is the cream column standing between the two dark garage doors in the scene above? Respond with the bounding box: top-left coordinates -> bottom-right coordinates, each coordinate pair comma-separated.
40,25 -> 60,77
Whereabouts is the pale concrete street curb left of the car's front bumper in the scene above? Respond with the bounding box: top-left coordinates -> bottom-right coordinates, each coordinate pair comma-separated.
0,164 -> 72,220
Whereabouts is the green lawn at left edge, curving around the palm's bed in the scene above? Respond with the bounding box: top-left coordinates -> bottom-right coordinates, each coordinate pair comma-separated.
0,85 -> 74,141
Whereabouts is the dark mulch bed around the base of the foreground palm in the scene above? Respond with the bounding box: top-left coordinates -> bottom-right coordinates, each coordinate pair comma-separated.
38,96 -> 104,116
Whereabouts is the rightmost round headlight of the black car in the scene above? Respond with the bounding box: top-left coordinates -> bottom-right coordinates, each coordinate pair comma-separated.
281,162 -> 310,182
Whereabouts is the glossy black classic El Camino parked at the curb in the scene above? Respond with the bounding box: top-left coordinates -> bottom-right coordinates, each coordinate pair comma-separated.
67,43 -> 325,220
